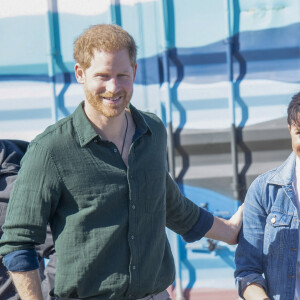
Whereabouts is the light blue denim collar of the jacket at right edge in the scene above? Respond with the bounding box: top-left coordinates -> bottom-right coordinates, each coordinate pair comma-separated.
267,152 -> 296,185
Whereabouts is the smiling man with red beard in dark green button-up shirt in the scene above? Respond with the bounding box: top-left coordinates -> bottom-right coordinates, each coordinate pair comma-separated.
0,25 -> 242,300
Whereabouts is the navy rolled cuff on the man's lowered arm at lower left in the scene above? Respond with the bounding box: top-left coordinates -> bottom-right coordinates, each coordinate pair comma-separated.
3,249 -> 39,272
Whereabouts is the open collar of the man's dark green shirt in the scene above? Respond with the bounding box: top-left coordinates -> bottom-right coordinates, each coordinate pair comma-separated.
73,101 -> 152,147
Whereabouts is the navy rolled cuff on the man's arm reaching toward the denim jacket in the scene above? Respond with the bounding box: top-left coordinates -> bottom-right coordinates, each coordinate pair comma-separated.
182,207 -> 214,243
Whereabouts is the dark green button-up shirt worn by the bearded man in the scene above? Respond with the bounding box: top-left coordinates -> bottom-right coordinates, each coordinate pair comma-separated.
0,105 -> 200,300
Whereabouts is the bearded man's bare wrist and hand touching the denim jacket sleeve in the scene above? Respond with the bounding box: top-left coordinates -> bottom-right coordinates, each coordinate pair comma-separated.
205,204 -> 244,245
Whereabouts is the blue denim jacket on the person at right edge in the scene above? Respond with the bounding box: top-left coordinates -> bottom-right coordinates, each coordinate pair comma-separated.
235,153 -> 299,300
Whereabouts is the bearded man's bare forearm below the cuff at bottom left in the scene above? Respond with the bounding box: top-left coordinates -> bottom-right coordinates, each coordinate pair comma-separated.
9,269 -> 43,300
